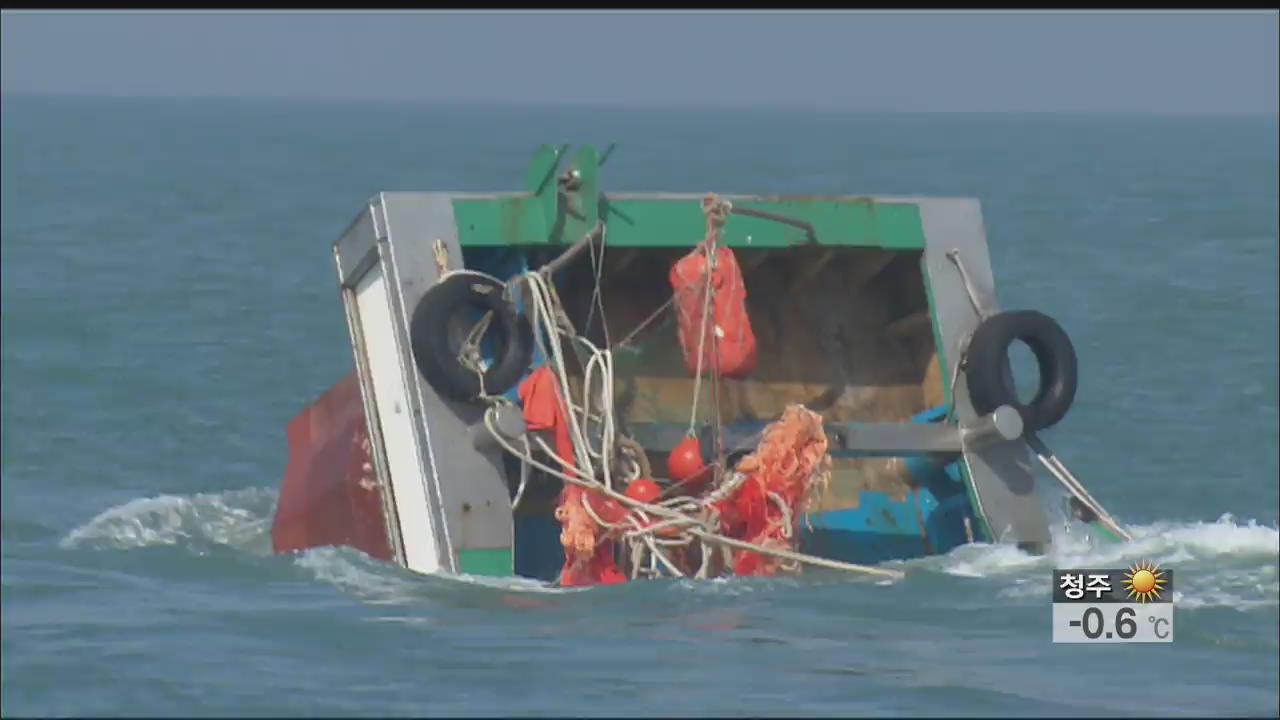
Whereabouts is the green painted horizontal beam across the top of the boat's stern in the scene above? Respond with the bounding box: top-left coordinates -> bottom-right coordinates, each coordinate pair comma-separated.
453,193 -> 924,250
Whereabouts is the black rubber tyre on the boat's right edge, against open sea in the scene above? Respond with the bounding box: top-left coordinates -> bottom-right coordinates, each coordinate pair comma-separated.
965,310 -> 1076,432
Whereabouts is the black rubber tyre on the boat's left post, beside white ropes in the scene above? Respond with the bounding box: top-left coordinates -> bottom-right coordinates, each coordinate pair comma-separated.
410,274 -> 534,401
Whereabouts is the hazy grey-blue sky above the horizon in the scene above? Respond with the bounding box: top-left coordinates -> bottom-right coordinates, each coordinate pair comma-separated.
0,12 -> 1280,115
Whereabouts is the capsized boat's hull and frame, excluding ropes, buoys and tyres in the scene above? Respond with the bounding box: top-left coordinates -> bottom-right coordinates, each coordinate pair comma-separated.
273,154 -> 1080,579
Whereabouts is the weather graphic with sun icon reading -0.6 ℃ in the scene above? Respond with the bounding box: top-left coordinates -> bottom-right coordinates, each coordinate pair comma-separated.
1053,560 -> 1174,643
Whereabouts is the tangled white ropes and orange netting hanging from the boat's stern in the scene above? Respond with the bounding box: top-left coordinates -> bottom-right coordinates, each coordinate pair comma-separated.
484,220 -> 902,582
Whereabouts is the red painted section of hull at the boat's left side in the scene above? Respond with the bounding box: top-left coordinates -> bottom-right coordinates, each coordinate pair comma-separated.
271,370 -> 393,561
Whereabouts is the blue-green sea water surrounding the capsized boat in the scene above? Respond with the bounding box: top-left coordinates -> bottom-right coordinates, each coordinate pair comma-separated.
0,96 -> 1280,717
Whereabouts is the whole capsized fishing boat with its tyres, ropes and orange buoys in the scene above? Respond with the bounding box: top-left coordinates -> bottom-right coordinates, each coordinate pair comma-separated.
271,146 -> 1128,585
